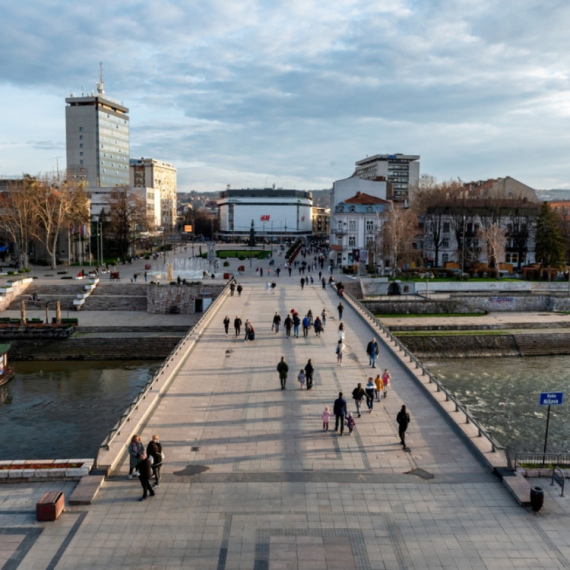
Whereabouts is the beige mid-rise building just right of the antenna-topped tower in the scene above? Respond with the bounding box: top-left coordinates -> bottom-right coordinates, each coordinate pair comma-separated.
130,158 -> 177,231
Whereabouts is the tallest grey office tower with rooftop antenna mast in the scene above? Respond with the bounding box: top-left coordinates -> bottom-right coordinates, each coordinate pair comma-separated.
65,67 -> 130,187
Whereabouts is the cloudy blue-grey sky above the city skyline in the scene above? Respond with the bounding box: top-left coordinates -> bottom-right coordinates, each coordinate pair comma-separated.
0,0 -> 570,191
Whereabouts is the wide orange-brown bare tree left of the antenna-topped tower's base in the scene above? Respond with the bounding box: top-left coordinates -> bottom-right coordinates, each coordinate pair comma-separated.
33,173 -> 89,269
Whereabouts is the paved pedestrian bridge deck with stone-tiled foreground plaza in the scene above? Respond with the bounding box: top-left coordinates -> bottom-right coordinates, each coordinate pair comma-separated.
0,277 -> 570,570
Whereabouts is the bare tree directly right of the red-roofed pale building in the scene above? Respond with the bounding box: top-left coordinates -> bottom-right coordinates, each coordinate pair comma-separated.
381,203 -> 420,276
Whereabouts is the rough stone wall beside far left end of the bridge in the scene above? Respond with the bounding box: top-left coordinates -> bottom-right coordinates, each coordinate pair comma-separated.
147,283 -> 225,315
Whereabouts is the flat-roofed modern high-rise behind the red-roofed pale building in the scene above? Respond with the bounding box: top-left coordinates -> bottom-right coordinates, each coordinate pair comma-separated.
353,154 -> 420,202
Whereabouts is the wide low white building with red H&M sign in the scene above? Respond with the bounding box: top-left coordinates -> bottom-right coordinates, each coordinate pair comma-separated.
218,188 -> 313,241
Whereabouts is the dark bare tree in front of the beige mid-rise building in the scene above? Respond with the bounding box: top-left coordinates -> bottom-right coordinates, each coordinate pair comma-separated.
103,186 -> 151,260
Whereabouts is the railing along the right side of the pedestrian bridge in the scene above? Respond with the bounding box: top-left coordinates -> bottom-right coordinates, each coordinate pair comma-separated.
344,291 -> 512,462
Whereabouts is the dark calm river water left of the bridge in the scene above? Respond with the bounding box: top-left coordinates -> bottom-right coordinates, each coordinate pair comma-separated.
0,361 -> 160,460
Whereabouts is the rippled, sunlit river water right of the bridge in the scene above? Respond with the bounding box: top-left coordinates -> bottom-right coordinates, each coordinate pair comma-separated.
424,356 -> 570,453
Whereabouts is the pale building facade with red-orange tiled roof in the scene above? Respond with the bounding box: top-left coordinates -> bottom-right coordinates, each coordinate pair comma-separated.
330,192 -> 390,268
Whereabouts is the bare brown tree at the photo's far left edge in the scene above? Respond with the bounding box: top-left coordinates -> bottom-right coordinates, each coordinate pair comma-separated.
0,174 -> 40,269
